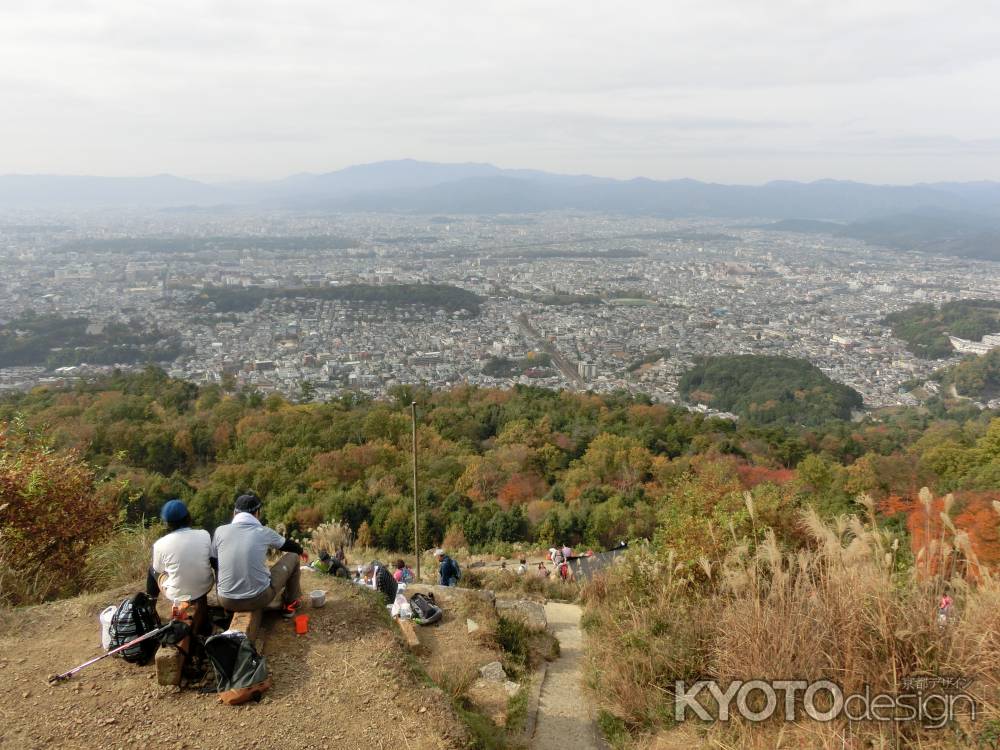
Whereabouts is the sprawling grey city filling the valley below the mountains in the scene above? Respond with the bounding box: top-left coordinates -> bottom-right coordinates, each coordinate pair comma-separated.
0,211 -> 1000,408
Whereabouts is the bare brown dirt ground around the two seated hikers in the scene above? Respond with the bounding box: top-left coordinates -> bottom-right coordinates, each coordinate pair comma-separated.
0,573 -> 468,750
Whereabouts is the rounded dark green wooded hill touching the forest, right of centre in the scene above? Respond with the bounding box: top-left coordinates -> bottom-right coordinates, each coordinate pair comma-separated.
680,355 -> 862,425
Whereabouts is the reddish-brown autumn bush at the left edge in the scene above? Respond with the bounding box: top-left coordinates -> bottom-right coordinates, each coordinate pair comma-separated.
0,424 -> 116,604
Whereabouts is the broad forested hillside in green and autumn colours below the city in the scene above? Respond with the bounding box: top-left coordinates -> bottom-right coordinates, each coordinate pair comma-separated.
0,368 -> 1000,600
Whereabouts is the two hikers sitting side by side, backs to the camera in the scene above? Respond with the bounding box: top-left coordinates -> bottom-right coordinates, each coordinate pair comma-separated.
146,495 -> 303,617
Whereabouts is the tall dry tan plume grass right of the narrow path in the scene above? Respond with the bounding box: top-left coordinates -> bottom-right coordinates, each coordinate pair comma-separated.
584,493 -> 1000,748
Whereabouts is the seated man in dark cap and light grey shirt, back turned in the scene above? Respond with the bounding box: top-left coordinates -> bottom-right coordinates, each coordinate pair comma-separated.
212,495 -> 302,617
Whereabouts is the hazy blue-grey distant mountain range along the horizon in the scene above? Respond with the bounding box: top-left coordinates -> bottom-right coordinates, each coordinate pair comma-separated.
0,159 -> 1000,222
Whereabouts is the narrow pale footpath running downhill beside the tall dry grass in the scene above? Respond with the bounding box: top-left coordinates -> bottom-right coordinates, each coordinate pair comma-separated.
531,602 -> 604,750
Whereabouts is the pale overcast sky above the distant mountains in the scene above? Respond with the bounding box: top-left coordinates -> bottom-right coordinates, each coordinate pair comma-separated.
0,0 -> 1000,183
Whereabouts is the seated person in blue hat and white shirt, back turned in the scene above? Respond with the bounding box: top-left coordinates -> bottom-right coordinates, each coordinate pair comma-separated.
146,500 -> 215,602
